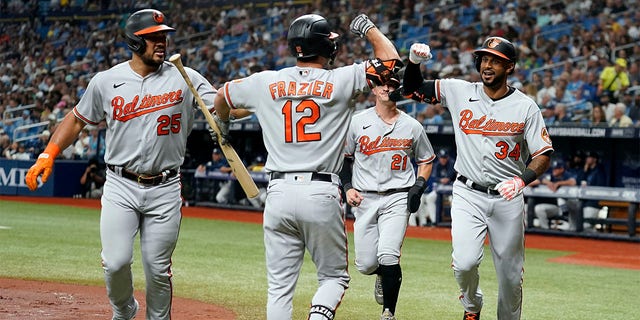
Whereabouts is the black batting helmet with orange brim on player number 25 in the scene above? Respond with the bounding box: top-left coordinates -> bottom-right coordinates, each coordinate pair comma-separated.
124,9 -> 176,53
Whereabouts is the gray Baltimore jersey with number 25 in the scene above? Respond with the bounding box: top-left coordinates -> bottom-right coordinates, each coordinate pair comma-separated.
73,62 -> 215,174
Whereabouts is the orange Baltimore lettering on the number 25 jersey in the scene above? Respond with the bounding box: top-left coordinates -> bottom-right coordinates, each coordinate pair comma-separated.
111,90 -> 184,122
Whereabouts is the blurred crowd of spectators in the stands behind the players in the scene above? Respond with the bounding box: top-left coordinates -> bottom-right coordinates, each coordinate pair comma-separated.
0,0 -> 640,165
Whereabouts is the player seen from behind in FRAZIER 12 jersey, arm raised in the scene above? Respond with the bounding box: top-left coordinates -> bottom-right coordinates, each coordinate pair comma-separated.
210,14 -> 399,320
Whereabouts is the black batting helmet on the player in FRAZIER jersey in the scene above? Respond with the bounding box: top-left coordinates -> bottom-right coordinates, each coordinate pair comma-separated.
287,14 -> 338,63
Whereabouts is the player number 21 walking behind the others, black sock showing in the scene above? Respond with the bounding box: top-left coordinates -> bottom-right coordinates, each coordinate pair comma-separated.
341,81 -> 435,320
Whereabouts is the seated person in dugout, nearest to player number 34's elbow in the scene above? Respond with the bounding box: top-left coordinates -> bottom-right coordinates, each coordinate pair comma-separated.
530,160 -> 577,230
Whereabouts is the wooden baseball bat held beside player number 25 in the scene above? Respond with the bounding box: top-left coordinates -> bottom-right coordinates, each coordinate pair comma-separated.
169,53 -> 260,198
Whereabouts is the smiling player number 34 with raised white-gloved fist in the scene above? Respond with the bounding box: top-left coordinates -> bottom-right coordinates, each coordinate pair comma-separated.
394,37 -> 553,320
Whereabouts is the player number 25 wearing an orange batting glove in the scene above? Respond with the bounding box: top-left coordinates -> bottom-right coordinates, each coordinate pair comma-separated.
26,9 -> 218,320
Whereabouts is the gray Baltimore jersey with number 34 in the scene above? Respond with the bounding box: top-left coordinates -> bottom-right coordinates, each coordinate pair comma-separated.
435,79 -> 553,187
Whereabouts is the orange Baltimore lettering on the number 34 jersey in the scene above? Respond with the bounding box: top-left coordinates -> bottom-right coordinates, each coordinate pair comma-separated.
459,109 -> 525,136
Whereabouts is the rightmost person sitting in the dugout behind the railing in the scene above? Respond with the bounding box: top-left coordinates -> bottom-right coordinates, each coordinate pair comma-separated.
569,151 -> 607,231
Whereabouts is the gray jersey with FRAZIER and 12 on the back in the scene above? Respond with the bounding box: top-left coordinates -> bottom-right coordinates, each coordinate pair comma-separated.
225,64 -> 369,173
